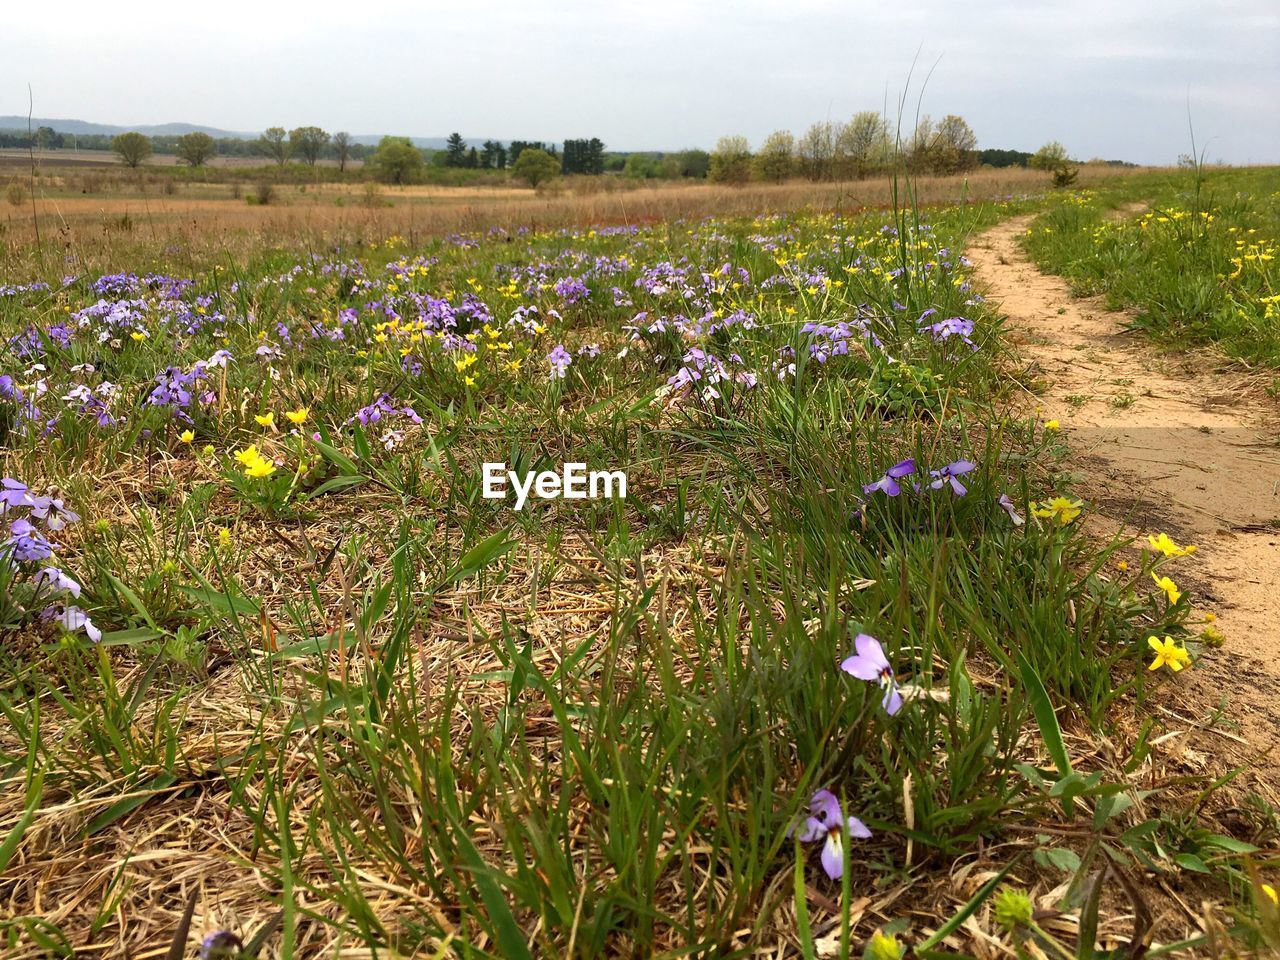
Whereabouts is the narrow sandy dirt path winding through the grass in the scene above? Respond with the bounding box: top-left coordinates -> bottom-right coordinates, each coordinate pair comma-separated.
968,218 -> 1280,780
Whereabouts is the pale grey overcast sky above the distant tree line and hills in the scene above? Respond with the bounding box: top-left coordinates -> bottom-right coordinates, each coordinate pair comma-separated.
0,0 -> 1280,163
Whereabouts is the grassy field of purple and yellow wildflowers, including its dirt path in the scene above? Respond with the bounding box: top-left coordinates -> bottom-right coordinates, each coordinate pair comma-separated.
0,161 -> 1280,960
